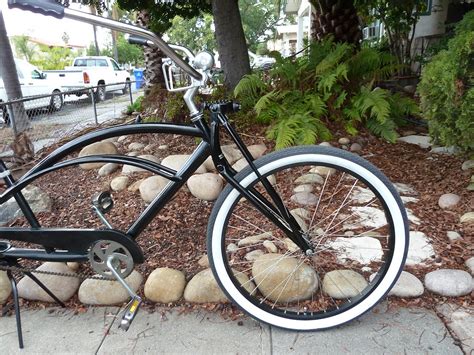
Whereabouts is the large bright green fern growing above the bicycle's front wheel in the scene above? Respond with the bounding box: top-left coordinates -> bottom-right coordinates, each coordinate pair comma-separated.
235,40 -> 417,148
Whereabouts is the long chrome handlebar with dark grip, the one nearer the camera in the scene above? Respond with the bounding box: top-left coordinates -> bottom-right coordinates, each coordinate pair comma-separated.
8,0 -> 203,81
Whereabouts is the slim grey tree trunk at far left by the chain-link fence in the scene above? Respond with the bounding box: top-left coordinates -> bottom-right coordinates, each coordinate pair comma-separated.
0,10 -> 34,163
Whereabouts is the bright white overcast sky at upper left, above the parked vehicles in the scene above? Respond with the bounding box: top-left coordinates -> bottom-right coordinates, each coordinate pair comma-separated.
0,0 -> 110,47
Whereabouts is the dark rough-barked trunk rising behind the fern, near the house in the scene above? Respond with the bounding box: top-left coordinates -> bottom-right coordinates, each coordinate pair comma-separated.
310,0 -> 362,46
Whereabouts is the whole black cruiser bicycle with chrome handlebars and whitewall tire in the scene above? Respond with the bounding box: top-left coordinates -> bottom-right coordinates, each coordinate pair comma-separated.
0,0 -> 408,350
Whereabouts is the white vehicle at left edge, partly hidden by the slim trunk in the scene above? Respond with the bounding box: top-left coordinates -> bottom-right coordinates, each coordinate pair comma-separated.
0,59 -> 64,123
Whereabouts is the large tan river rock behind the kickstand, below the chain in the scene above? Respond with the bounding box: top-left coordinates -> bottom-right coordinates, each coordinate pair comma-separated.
18,262 -> 80,302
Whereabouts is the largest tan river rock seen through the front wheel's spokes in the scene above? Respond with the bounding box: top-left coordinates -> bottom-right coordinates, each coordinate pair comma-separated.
252,254 -> 318,302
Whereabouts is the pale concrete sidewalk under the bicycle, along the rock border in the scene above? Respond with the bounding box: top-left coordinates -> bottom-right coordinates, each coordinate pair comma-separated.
0,304 -> 463,355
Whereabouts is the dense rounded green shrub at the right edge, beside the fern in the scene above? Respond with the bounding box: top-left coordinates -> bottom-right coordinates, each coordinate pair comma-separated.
418,11 -> 474,151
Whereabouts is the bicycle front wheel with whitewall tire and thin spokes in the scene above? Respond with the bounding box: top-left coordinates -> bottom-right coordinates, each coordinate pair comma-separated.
207,146 -> 408,330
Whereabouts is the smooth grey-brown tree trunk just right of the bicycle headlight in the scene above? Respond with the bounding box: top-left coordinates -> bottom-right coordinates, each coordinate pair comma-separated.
212,0 -> 250,90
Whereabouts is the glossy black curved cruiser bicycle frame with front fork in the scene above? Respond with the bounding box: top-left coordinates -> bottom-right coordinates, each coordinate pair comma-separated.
0,105 -> 310,262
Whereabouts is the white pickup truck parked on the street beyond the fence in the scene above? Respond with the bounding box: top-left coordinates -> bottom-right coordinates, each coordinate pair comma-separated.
45,57 -> 130,101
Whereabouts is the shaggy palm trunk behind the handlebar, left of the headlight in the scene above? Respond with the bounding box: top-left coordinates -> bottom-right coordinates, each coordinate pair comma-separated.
137,10 -> 165,94
